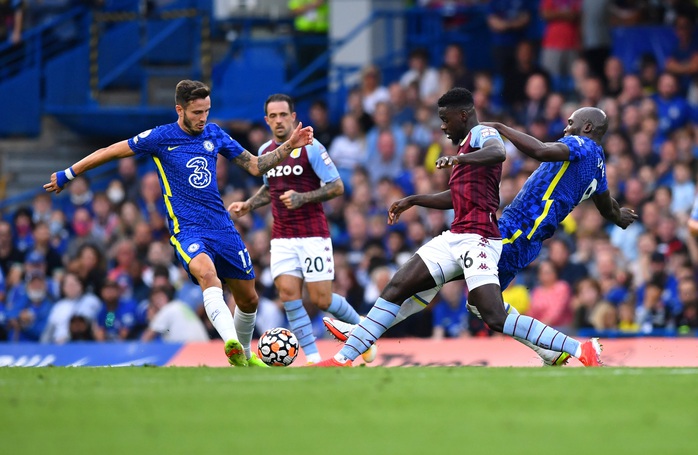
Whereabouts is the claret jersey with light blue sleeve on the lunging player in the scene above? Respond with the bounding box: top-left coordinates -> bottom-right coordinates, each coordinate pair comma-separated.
448,125 -> 504,238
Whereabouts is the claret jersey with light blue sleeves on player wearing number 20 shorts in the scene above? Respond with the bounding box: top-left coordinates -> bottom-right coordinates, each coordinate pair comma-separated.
259,139 -> 339,239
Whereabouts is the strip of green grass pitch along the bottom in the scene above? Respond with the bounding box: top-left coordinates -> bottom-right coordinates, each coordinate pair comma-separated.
0,367 -> 698,455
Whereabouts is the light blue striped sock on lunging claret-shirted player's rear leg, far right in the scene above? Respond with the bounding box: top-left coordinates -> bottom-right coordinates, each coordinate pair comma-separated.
502,314 -> 580,357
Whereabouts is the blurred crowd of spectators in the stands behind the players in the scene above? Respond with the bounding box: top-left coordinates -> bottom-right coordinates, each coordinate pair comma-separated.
0,0 -> 698,342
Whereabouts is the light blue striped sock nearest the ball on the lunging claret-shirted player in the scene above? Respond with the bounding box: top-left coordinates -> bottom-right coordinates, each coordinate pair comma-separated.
338,298 -> 400,360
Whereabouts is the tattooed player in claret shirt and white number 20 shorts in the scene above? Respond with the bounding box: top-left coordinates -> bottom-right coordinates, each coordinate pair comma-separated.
228,94 -> 375,364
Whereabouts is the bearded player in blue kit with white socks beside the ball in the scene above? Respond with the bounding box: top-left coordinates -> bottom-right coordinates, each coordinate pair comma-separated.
44,80 -> 313,367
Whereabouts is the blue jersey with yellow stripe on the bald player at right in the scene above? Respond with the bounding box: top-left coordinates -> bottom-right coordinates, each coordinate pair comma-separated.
502,136 -> 608,241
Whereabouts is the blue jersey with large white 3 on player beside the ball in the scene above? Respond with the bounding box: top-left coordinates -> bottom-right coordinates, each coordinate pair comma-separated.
128,122 -> 244,235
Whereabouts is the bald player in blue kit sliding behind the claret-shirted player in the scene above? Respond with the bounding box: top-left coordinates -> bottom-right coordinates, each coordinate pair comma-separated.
324,107 -> 637,365
